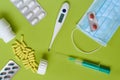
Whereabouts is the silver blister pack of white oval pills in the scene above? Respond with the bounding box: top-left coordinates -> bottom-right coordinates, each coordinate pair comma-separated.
11,0 -> 46,25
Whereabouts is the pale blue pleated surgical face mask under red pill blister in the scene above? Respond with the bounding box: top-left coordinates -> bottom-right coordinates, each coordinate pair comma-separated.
71,0 -> 120,53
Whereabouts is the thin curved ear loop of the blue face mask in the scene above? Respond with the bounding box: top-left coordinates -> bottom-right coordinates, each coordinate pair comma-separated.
71,28 -> 102,54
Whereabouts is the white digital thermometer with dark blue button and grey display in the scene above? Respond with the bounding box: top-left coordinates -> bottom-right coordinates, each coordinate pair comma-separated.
48,2 -> 69,51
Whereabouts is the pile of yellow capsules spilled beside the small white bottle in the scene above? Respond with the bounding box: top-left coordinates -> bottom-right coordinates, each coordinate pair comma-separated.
12,35 -> 38,72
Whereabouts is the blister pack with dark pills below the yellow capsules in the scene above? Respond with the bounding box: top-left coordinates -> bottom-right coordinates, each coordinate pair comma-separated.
0,60 -> 20,80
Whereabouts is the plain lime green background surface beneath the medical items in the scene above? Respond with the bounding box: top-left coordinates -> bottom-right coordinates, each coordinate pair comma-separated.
0,0 -> 120,80
